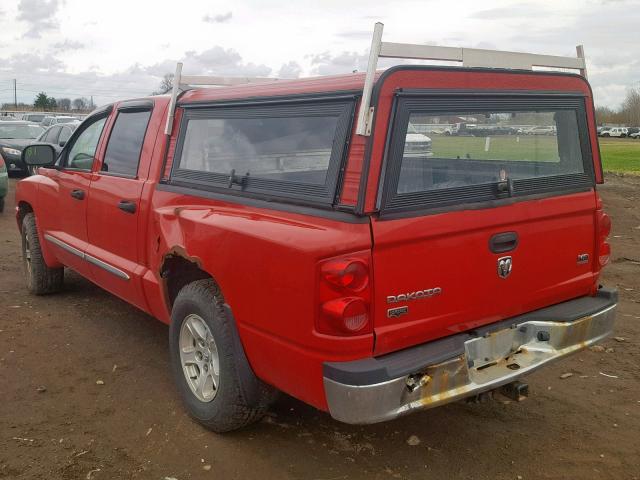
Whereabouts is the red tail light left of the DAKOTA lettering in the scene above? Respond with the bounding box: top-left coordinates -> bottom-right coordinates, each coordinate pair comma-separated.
316,252 -> 372,336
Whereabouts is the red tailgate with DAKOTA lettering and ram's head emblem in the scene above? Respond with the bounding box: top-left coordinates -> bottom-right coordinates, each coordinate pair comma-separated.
373,192 -> 597,354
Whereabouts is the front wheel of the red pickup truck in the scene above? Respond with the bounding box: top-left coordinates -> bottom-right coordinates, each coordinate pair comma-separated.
21,213 -> 64,295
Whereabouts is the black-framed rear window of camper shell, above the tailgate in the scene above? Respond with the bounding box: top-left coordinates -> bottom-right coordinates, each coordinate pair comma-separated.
381,97 -> 593,214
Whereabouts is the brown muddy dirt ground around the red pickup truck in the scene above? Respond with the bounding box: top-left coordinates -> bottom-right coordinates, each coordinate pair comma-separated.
0,176 -> 640,480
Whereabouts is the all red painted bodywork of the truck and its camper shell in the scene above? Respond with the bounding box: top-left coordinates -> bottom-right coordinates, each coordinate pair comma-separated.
16,69 -> 601,409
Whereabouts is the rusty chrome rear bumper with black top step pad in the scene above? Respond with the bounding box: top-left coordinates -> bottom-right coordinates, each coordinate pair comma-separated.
324,290 -> 617,423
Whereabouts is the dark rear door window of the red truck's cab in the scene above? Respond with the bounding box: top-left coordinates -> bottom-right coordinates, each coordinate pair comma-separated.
102,110 -> 151,177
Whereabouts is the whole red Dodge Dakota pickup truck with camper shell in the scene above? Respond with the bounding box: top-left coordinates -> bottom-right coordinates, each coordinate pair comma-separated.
16,31 -> 617,432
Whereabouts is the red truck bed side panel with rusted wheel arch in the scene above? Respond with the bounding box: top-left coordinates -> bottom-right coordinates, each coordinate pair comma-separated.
150,190 -> 373,408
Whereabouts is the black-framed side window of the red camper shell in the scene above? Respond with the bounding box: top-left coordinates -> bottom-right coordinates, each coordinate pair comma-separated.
170,99 -> 354,205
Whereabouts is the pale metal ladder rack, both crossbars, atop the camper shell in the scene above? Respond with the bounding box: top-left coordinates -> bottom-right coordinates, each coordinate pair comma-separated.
165,22 -> 587,136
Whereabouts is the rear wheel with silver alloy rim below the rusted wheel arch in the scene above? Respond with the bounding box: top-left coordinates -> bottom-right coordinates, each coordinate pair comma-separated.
169,279 -> 276,433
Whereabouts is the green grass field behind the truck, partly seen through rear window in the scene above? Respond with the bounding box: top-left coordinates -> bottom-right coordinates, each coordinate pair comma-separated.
424,135 -> 640,175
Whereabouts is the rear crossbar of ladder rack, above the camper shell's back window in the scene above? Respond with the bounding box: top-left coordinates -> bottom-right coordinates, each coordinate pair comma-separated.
356,22 -> 587,136
